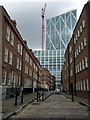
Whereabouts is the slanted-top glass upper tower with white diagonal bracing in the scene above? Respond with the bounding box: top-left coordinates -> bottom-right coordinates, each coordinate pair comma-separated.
46,10 -> 76,50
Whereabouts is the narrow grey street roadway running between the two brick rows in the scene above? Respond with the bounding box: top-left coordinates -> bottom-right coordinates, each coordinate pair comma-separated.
11,94 -> 88,120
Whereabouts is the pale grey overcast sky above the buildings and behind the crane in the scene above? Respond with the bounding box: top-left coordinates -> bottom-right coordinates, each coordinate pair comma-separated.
0,0 -> 88,49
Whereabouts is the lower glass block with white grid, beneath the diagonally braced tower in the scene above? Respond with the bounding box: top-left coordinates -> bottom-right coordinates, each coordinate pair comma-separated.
34,49 -> 64,86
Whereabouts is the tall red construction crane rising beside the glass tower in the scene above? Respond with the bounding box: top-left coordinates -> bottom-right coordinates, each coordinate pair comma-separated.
41,3 -> 47,50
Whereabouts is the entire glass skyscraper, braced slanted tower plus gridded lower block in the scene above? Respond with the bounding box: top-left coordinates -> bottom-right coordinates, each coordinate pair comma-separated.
34,10 -> 77,88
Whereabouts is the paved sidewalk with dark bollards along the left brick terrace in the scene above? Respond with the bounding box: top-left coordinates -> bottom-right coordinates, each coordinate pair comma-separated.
0,92 -> 52,118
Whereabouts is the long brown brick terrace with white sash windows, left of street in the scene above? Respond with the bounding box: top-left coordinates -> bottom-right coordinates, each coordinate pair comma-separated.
0,6 -> 41,98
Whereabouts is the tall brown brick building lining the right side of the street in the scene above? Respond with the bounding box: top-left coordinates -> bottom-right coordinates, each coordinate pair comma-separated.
61,2 -> 90,98
